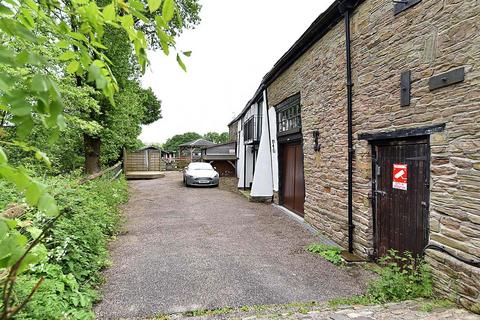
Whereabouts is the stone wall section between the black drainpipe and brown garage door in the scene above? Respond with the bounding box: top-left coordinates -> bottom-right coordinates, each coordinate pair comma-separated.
267,23 -> 347,252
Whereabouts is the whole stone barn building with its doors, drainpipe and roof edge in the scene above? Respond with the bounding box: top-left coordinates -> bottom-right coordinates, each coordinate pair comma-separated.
231,0 -> 480,307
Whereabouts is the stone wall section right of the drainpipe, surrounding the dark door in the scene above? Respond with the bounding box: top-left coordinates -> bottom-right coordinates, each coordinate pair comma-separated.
352,0 -> 480,305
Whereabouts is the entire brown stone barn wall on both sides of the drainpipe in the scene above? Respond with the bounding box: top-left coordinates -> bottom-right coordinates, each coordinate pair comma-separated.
268,0 -> 480,307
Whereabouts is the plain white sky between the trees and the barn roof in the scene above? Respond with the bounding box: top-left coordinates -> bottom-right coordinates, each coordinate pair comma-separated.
140,0 -> 333,144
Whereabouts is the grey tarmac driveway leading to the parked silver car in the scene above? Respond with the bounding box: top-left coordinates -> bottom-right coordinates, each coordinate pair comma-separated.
95,173 -> 368,319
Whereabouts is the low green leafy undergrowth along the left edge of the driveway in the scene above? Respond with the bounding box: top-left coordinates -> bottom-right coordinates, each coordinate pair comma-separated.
0,176 -> 127,319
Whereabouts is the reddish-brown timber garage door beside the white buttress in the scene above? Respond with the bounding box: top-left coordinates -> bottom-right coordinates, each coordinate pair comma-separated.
281,142 -> 305,217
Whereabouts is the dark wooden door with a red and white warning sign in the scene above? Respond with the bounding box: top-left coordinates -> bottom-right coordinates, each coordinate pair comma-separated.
373,138 -> 430,257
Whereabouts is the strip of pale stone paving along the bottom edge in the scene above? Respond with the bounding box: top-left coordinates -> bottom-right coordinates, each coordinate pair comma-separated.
166,300 -> 480,320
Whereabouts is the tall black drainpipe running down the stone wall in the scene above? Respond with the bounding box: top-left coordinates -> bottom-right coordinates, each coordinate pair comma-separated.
344,1 -> 355,253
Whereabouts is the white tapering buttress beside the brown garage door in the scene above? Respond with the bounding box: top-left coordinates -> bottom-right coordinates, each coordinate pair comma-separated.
250,95 -> 273,197
